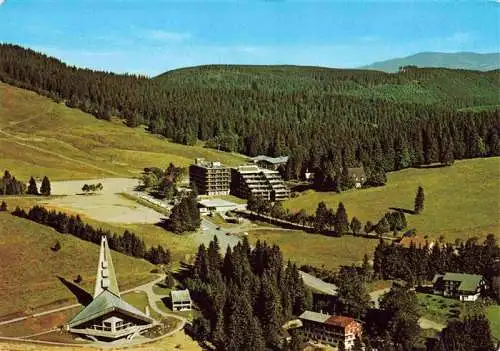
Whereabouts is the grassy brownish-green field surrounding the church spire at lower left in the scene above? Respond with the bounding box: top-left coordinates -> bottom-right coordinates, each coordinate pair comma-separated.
0,213 -> 154,319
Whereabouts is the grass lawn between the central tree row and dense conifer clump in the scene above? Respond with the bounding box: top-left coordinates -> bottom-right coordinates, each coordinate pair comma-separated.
248,230 -> 378,269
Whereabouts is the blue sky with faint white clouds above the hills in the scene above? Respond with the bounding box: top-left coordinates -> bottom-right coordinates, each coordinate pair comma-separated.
0,0 -> 500,75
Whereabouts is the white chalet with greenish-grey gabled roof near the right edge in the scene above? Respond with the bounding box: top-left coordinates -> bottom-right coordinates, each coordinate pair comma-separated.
432,273 -> 485,301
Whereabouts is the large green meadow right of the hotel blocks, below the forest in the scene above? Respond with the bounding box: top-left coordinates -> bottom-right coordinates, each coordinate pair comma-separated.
285,157 -> 500,242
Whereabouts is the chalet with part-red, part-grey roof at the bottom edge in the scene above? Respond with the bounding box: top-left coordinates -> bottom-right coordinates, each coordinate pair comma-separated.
299,311 -> 362,350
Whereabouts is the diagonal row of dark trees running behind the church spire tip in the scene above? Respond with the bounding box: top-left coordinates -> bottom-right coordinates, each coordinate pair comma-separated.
12,206 -> 170,264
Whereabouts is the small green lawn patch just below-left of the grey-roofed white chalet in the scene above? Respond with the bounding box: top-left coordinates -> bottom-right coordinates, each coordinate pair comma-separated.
417,293 -> 462,324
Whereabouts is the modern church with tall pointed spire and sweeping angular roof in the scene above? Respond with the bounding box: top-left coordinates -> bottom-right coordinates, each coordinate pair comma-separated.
67,236 -> 156,340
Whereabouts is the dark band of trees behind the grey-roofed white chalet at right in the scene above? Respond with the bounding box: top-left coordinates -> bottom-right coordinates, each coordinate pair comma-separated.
373,234 -> 500,286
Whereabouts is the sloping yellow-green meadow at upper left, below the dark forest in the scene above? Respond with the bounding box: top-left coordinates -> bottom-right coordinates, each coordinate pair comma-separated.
0,83 -> 244,180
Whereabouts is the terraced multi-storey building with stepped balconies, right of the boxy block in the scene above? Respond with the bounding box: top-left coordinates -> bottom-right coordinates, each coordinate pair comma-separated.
231,165 -> 290,201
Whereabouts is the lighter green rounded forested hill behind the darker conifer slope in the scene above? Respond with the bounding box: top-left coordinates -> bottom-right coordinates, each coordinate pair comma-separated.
155,65 -> 500,106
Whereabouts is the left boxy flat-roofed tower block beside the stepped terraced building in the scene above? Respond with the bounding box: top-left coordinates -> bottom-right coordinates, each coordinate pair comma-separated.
189,158 -> 231,195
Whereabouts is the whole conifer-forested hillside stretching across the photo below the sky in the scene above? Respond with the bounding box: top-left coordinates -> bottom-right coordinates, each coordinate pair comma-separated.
0,45 -> 500,189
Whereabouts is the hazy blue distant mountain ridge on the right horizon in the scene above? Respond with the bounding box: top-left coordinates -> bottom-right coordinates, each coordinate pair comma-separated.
360,52 -> 500,73
